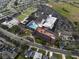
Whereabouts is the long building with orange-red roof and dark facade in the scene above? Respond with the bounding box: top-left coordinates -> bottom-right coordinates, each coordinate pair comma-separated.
35,27 -> 55,43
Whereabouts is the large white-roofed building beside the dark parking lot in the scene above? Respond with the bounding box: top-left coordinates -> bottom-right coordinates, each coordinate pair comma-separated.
38,15 -> 57,29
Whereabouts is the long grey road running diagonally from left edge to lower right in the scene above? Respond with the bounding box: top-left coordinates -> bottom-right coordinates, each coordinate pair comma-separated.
0,28 -> 79,56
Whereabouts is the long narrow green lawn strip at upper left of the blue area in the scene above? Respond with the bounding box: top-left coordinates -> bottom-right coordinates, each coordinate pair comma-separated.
17,6 -> 37,21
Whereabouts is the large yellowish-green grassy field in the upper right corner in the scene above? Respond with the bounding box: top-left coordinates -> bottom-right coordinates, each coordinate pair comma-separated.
49,2 -> 79,22
